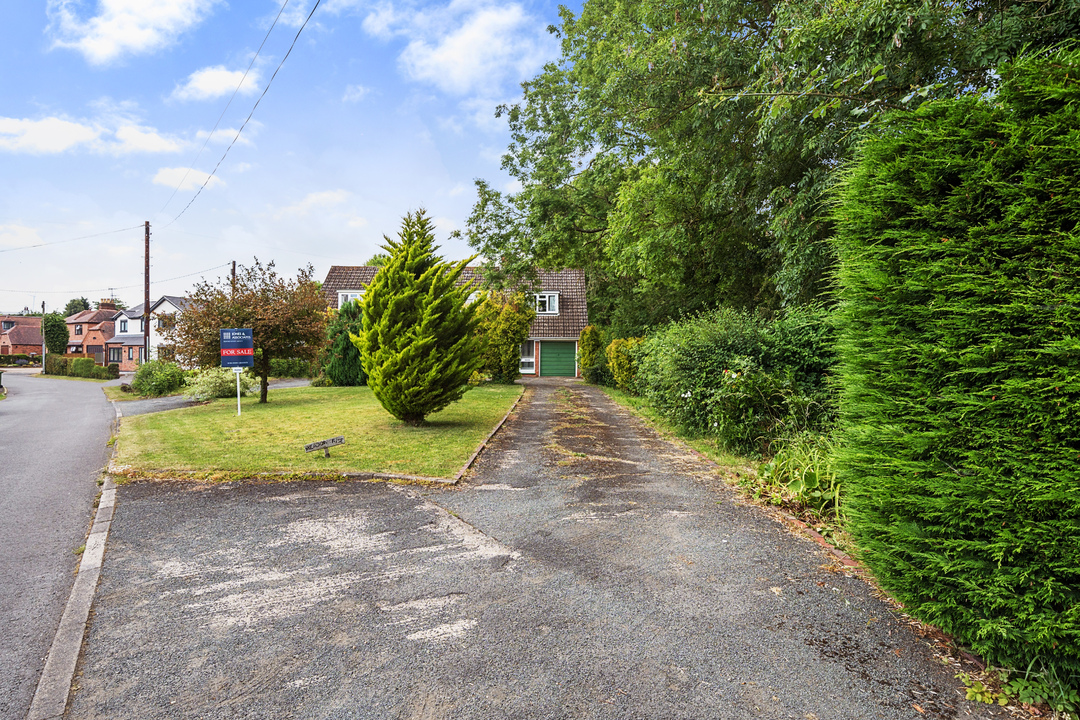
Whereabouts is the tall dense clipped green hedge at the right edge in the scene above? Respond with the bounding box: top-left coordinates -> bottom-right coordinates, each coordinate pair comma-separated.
836,50 -> 1080,687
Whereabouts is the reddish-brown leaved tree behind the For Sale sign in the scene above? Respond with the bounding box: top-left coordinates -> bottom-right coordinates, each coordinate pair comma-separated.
166,258 -> 326,403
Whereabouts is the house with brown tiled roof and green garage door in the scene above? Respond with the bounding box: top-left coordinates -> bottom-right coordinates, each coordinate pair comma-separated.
323,266 -> 589,378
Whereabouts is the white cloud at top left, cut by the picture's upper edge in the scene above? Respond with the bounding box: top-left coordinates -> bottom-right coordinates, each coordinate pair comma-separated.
48,0 -> 218,65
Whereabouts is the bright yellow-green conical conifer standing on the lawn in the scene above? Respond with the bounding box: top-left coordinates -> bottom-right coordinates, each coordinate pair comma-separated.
351,209 -> 482,425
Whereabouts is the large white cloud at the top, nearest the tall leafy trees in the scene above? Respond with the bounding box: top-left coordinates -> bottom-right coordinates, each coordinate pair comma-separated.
373,0 -> 558,95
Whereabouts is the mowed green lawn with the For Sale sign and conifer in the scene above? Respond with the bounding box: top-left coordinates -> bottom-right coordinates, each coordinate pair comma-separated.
116,385 -> 523,477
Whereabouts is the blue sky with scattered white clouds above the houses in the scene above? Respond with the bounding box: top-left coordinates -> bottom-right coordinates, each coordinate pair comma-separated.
0,0 -> 577,312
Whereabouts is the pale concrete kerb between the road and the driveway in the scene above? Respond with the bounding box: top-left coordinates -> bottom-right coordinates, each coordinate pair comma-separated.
27,476 -> 117,720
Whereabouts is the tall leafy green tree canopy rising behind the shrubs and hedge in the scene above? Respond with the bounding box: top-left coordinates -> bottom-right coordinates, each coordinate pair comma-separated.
457,0 -> 1080,334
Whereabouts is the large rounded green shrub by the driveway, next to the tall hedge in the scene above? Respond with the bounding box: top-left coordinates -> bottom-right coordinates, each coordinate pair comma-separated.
634,308 -> 835,456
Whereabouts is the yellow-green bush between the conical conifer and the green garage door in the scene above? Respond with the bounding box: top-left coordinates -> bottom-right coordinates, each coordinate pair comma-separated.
477,291 -> 537,384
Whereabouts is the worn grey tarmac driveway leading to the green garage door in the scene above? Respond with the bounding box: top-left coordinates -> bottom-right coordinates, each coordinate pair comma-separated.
66,382 -> 1007,720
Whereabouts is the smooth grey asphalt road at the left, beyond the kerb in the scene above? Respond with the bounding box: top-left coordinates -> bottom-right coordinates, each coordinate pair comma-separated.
0,371 -> 114,720
